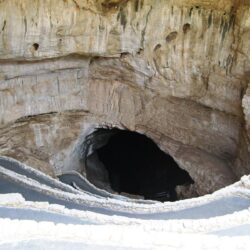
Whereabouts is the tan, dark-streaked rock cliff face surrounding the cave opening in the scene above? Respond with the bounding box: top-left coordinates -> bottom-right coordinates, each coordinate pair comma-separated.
0,0 -> 250,198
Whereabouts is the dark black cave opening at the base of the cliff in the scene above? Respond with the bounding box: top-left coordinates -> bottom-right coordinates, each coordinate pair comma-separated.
85,128 -> 194,201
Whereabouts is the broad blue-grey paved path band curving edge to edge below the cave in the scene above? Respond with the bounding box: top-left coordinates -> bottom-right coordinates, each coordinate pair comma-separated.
0,159 -> 250,220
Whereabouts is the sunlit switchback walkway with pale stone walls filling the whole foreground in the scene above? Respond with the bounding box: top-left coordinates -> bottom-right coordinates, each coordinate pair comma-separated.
0,157 -> 250,250
